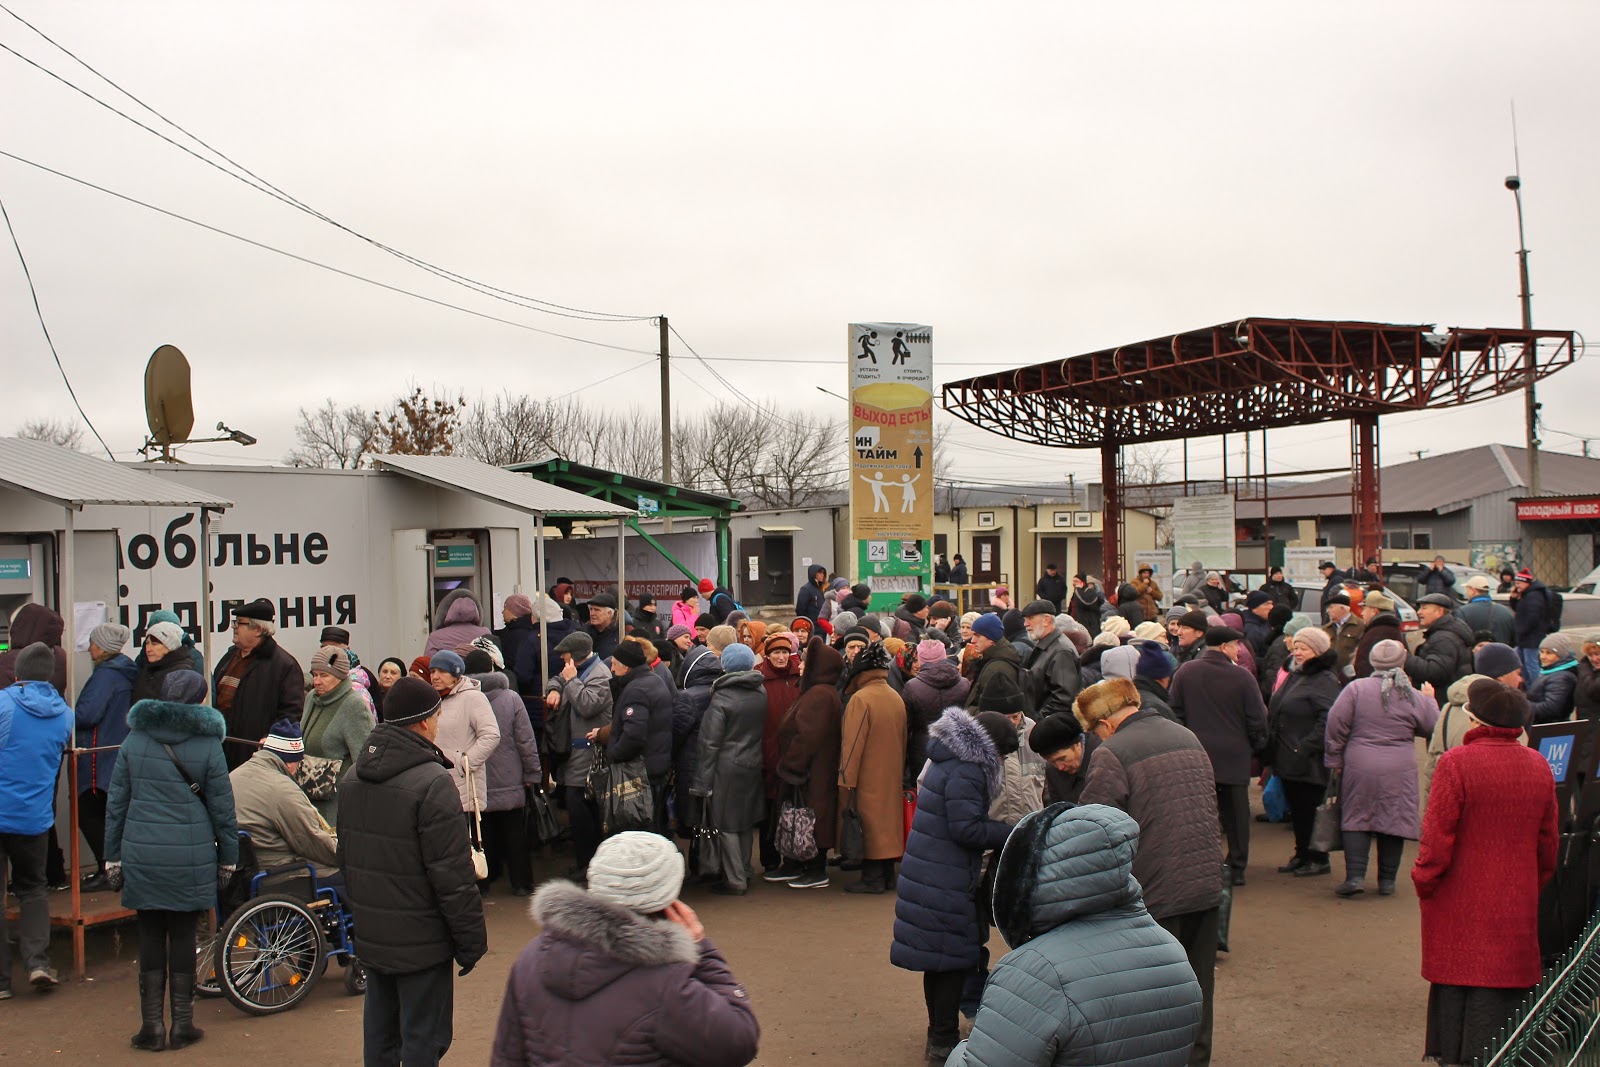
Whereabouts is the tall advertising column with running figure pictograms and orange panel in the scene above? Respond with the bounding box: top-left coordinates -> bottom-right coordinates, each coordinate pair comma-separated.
850,323 -> 933,611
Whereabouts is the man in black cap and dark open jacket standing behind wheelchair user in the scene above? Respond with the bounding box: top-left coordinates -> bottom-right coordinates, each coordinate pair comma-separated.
211,597 -> 306,771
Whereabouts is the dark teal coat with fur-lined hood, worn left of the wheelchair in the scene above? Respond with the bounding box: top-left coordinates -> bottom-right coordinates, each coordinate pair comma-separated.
106,701 -> 238,912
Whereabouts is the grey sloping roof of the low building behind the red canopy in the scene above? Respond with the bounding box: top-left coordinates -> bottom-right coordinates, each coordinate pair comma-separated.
1237,445 -> 1600,518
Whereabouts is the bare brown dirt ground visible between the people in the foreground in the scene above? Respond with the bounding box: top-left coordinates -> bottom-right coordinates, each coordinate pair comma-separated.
0,800 -> 1427,1067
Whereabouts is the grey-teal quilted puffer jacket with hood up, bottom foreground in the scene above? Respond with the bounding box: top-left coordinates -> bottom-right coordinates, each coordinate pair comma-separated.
947,803 -> 1200,1067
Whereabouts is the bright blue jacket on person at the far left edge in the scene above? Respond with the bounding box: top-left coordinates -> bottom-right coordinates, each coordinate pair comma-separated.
0,681 -> 72,837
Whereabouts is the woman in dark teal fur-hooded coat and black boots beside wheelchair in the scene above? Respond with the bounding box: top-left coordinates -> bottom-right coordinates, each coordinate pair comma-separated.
106,670 -> 238,1051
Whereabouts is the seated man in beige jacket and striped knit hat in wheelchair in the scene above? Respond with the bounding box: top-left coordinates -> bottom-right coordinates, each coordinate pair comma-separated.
227,718 -> 339,881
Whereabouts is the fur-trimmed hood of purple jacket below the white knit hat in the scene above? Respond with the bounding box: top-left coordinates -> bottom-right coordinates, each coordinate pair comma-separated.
528,880 -> 699,1000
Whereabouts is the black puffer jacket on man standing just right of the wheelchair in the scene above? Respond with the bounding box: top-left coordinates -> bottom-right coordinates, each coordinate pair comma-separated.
339,723 -> 488,974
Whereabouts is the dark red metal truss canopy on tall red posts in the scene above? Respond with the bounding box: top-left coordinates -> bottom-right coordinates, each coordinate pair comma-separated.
942,318 -> 1579,585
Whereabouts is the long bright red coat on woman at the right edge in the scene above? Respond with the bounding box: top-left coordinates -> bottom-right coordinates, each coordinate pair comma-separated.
1411,726 -> 1557,989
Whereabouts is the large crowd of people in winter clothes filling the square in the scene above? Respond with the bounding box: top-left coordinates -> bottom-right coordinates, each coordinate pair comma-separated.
0,557 -> 1574,1065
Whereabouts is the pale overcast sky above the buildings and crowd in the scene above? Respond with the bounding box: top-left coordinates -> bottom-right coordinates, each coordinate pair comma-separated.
0,0 -> 1600,482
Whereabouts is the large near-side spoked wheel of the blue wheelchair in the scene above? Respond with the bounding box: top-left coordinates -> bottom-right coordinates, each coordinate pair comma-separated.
216,896 -> 326,1016
